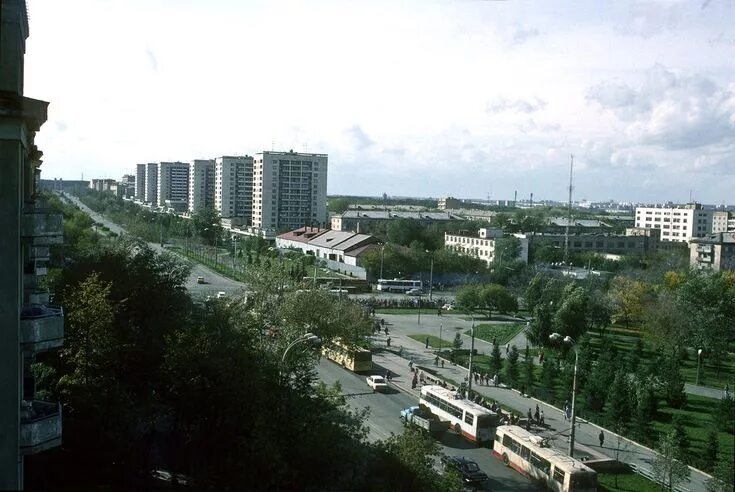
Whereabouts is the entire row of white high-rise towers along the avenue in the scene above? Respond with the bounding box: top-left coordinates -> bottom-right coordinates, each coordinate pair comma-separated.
134,151 -> 328,231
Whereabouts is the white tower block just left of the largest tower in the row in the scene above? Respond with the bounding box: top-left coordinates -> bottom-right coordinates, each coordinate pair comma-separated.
214,155 -> 253,219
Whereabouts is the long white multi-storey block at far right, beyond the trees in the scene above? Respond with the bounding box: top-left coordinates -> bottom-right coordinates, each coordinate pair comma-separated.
635,203 -> 713,242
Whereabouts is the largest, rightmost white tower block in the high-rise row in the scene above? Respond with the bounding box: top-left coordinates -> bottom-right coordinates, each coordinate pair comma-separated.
253,151 -> 328,230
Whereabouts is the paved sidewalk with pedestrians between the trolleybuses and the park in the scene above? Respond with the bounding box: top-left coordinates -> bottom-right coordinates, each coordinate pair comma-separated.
373,315 -> 710,491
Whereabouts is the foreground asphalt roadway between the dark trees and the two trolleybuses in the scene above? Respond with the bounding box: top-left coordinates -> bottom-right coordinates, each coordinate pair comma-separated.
317,359 -> 543,491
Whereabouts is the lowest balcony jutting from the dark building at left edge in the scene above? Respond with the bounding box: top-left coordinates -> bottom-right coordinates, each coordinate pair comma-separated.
20,400 -> 61,454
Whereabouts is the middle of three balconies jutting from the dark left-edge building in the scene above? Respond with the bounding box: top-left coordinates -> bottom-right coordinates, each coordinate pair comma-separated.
20,304 -> 64,352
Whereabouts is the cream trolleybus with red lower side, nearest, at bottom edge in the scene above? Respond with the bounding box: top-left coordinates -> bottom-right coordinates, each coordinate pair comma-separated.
493,425 -> 597,492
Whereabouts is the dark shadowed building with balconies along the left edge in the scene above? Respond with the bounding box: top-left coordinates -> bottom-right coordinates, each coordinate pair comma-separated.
0,0 -> 64,490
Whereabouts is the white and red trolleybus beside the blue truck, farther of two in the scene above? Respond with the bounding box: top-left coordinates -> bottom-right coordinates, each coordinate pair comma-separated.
419,386 -> 498,443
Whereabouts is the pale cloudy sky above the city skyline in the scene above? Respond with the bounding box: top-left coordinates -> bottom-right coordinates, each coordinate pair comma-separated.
25,0 -> 735,205
